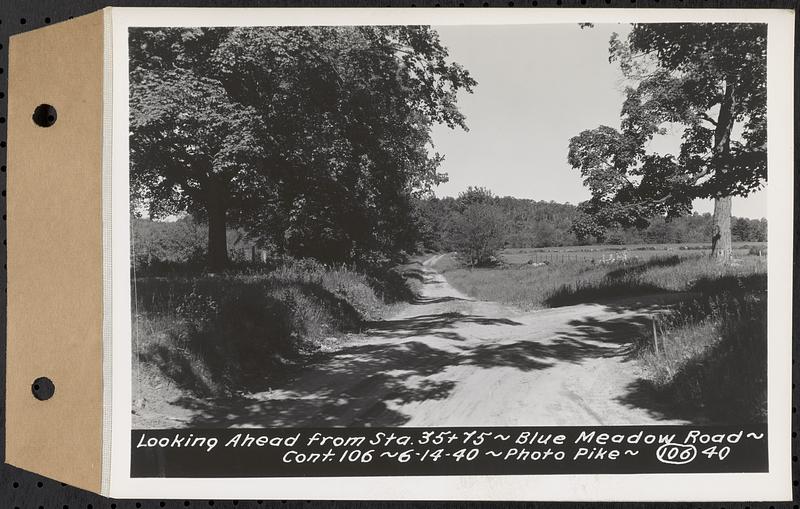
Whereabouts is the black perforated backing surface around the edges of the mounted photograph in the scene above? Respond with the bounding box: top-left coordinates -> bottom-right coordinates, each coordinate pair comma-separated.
0,0 -> 800,509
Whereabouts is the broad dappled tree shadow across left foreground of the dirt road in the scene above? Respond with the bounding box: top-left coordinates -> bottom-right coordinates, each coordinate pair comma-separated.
175,341 -> 466,427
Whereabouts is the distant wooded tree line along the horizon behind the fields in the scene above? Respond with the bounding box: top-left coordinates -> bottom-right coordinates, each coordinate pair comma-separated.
131,189 -> 767,271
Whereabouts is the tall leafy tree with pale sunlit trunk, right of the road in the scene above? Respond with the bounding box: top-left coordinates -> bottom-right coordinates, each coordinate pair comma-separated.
568,23 -> 767,259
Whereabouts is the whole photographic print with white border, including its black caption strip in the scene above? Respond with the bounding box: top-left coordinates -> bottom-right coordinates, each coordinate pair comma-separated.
104,4 -> 793,500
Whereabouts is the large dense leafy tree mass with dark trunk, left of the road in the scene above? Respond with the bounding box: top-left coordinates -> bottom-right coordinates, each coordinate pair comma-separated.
130,26 -> 475,268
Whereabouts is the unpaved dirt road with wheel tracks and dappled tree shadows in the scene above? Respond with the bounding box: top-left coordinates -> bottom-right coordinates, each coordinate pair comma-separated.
134,255 -> 687,428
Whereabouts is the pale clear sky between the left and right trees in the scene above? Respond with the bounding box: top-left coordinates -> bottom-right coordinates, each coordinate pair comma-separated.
433,24 -> 767,218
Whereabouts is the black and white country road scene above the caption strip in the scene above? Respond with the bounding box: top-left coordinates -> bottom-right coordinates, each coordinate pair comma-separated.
129,19 -> 769,429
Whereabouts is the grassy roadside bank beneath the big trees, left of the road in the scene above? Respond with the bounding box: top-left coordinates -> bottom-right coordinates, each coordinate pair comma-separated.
132,260 -> 413,407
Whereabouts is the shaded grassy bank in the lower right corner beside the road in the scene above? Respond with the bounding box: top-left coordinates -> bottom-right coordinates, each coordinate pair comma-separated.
637,288 -> 767,423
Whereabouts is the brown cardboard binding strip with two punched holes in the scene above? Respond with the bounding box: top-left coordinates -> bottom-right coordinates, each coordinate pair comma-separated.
6,8 -> 104,491
